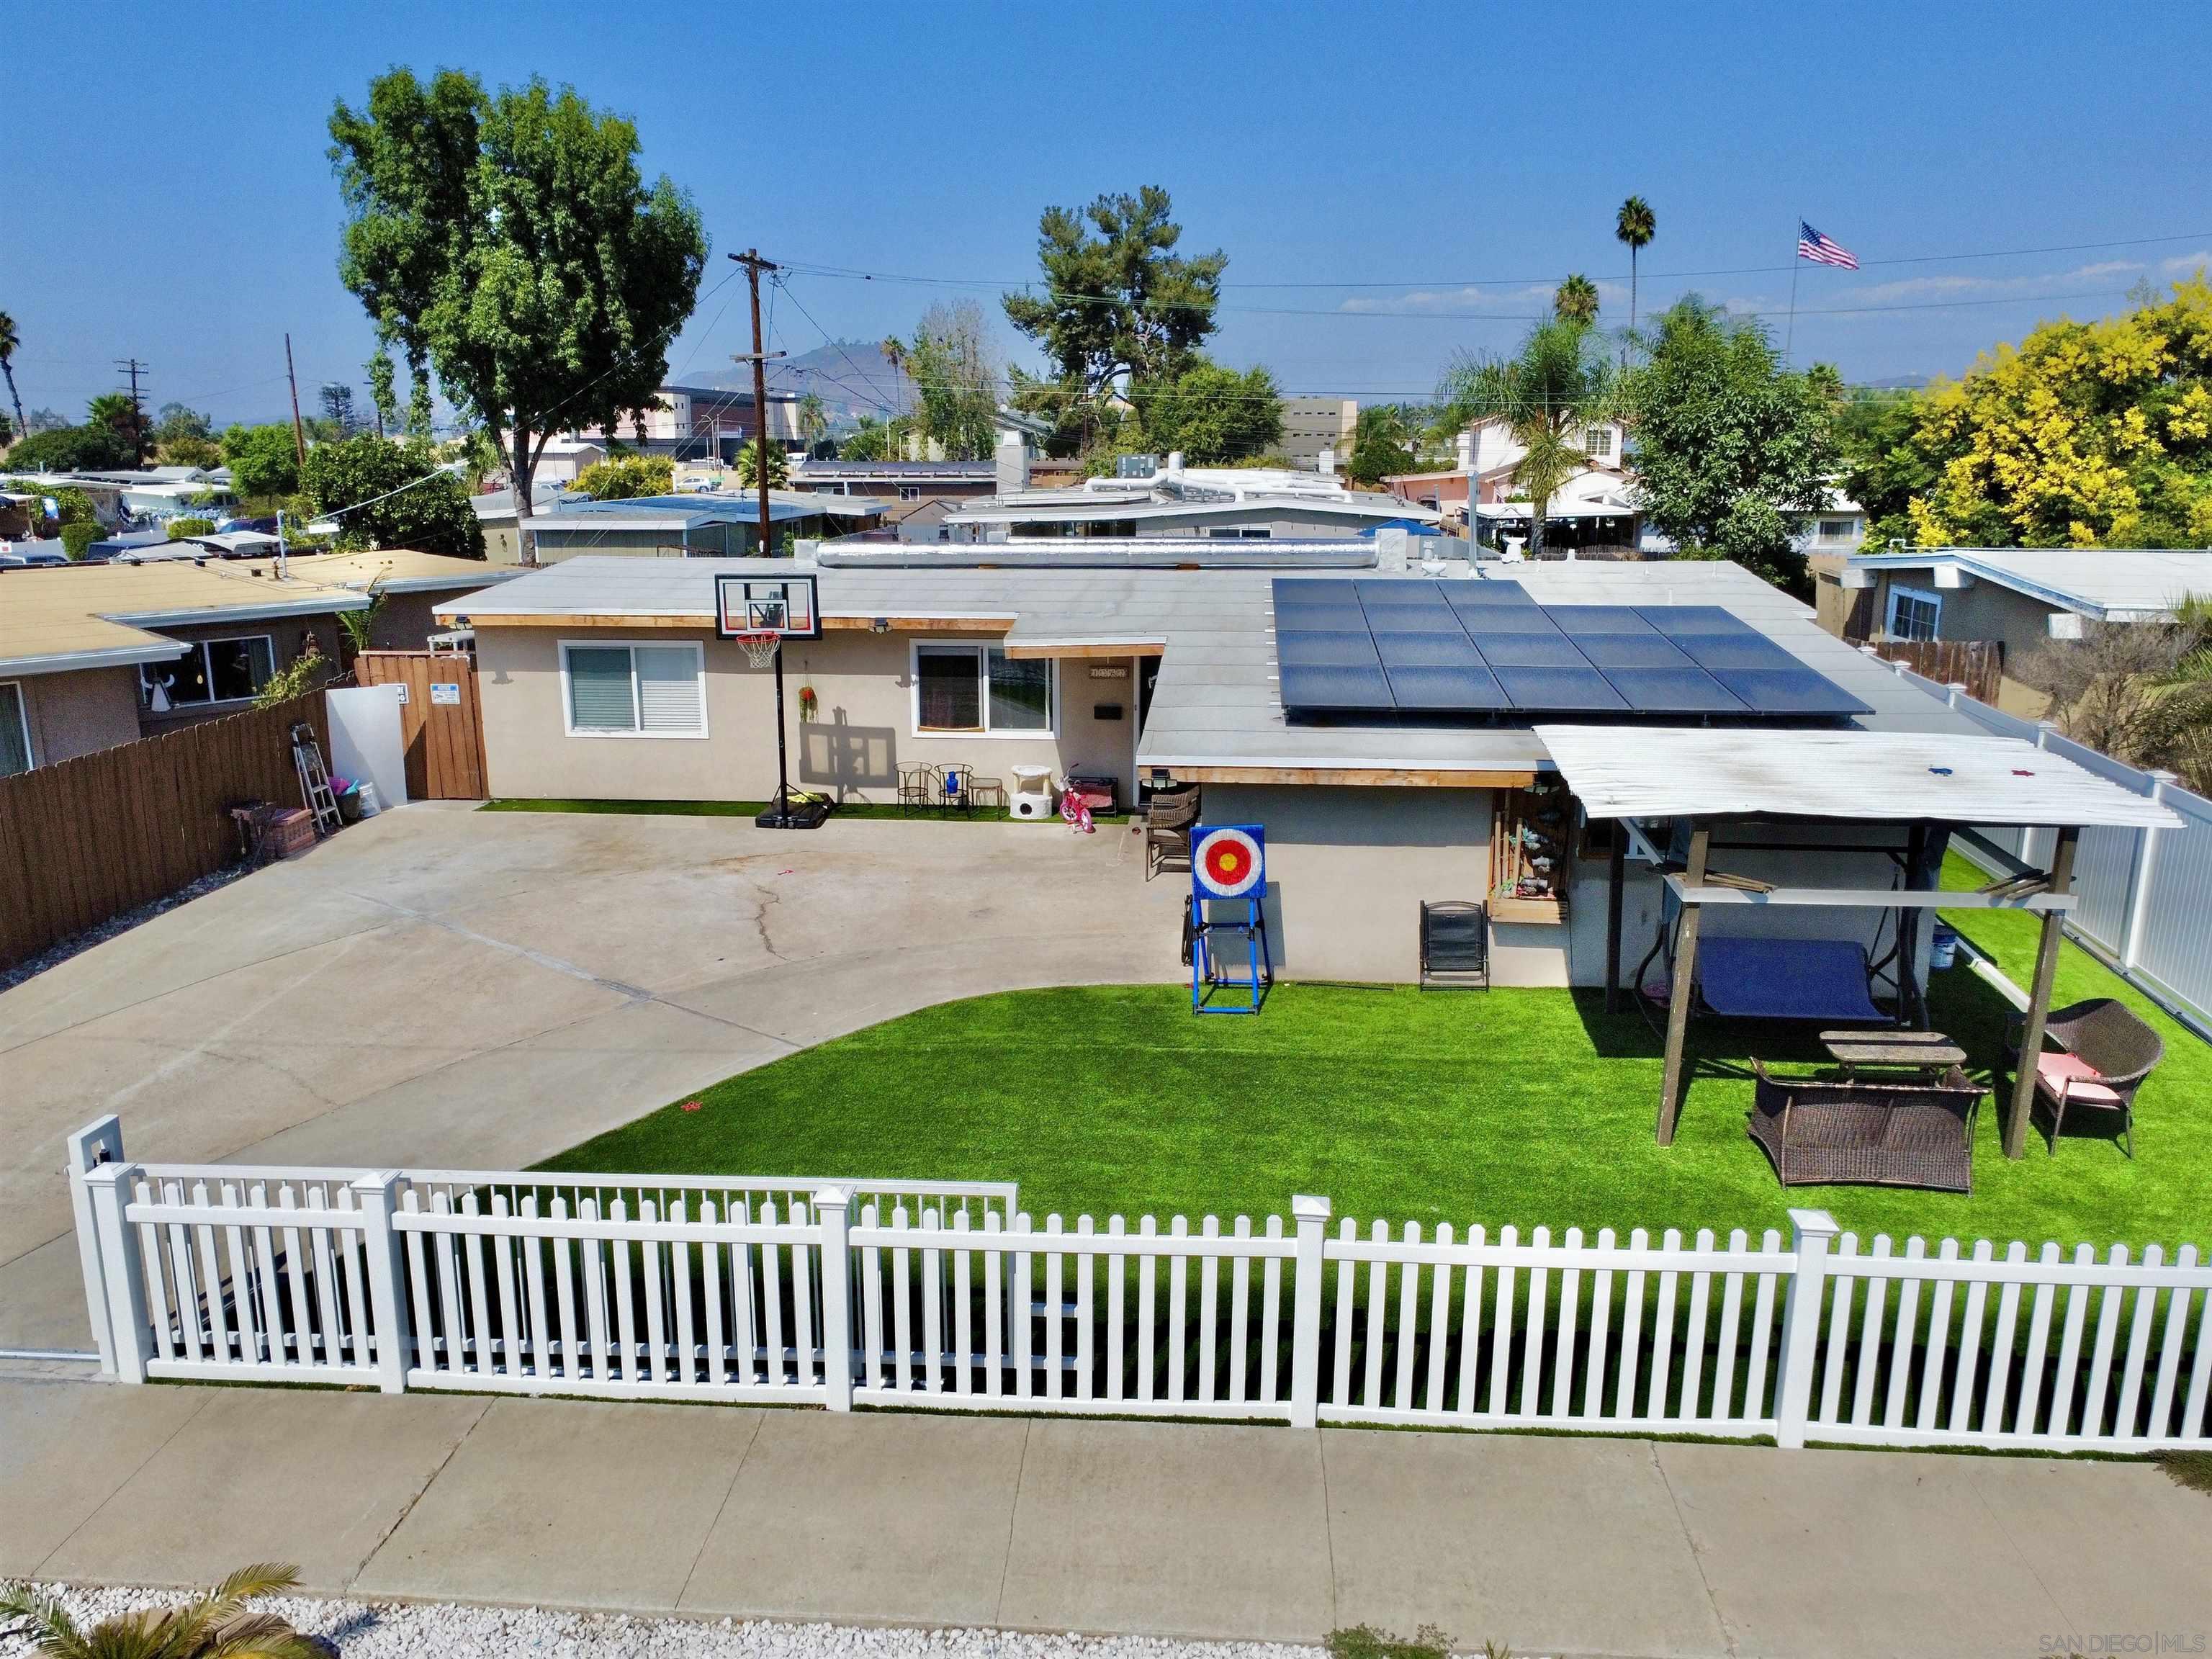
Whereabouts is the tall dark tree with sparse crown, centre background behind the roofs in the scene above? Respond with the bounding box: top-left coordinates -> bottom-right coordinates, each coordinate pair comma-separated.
1004,184 -> 1230,456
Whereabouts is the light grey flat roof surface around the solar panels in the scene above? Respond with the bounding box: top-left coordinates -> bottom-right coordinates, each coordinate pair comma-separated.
436,547 -> 1979,786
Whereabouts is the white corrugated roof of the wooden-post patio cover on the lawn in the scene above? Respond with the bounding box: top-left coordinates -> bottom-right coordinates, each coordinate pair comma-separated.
1535,726 -> 2181,827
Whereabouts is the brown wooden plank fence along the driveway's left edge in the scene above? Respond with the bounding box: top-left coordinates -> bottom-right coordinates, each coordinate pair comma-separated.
0,690 -> 330,966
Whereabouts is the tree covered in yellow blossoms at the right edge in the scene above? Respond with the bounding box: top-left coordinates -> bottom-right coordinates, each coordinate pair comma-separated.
1847,270 -> 2212,547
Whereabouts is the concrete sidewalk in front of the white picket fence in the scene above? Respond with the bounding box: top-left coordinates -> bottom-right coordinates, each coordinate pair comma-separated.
0,1376 -> 2212,1659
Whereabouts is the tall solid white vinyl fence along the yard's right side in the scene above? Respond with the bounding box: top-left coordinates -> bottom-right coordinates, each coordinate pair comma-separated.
1894,664 -> 2212,1031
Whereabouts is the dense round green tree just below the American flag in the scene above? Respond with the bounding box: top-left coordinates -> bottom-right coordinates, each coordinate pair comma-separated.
1624,295 -> 1838,597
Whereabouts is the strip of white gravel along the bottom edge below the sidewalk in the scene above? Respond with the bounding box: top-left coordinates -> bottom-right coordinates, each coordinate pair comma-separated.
0,1586 -> 1321,1659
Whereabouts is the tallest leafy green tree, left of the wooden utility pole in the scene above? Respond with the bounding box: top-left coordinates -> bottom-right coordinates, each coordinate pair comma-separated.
330,68 -> 708,562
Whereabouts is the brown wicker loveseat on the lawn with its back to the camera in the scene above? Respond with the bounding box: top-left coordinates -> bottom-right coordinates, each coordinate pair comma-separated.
1750,1059 -> 1984,1192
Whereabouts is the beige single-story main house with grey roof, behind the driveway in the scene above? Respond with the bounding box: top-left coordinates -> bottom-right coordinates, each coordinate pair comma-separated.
440,546 -> 1977,984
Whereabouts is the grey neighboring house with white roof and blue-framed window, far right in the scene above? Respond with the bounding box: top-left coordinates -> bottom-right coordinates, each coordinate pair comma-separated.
1814,547 -> 2212,719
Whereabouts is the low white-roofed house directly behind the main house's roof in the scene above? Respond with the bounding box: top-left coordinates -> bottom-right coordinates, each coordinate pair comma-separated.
945,456 -> 1438,542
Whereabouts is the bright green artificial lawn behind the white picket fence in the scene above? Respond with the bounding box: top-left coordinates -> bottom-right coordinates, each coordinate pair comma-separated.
544,865 -> 2212,1248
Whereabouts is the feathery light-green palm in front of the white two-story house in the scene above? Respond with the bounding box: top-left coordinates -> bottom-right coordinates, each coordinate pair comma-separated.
1436,316 -> 1619,553
